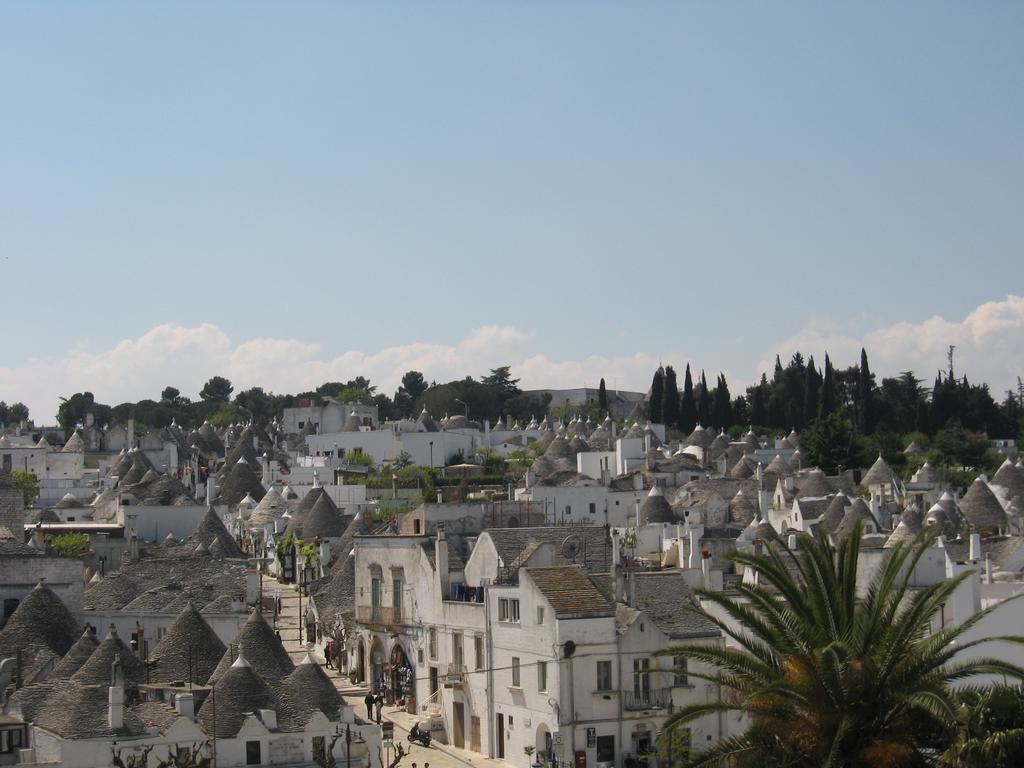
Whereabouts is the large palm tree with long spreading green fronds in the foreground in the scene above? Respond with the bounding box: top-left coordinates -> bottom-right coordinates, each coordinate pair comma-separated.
663,523 -> 1024,768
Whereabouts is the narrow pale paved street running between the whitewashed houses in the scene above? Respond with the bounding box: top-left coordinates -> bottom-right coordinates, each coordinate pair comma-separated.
266,583 -> 516,768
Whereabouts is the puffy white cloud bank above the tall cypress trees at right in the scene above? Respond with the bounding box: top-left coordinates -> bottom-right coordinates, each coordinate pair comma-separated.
757,294 -> 1024,399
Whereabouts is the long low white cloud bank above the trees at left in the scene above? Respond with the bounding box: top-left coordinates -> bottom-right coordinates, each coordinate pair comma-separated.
0,324 -> 657,422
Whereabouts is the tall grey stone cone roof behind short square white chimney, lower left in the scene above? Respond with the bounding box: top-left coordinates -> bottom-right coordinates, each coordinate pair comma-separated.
150,601 -> 227,685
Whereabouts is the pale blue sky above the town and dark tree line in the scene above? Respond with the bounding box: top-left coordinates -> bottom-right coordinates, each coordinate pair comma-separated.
0,2 -> 1024,421
